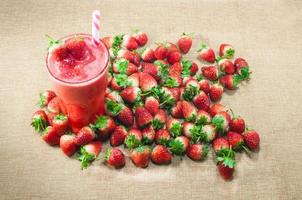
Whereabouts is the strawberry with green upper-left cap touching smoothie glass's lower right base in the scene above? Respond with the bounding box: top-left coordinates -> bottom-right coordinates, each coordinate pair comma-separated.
91,115 -> 116,140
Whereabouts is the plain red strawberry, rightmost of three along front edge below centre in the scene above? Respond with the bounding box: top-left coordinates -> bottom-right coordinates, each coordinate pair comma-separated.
151,145 -> 172,165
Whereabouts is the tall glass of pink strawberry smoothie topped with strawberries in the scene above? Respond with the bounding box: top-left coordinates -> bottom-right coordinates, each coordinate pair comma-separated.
46,34 -> 109,132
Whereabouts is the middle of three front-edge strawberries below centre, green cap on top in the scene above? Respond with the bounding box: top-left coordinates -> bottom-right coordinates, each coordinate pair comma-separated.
130,146 -> 151,168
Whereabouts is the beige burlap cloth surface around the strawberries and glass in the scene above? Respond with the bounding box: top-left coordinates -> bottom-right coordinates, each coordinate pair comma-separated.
0,0 -> 302,200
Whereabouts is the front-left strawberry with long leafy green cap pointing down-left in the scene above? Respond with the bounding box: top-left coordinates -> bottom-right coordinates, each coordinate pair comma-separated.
77,141 -> 102,169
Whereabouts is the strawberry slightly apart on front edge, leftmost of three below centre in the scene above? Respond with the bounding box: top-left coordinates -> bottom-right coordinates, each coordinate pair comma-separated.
104,148 -> 126,169
